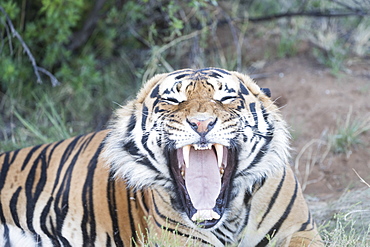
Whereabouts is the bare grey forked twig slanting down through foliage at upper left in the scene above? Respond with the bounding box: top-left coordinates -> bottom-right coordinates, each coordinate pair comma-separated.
0,6 -> 60,86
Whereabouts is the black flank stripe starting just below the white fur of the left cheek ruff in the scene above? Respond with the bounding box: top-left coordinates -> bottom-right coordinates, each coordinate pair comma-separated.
107,171 -> 123,246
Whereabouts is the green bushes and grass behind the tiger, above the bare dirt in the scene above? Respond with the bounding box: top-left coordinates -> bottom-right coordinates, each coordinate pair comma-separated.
0,0 -> 369,150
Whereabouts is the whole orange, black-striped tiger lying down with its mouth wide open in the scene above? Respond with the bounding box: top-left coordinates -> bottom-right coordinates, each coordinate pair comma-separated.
0,68 -> 324,247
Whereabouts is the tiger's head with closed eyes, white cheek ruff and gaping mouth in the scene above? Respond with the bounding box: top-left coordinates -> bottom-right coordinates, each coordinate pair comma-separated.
104,68 -> 289,228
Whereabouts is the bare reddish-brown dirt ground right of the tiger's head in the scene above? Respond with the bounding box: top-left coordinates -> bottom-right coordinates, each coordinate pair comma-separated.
256,55 -> 370,201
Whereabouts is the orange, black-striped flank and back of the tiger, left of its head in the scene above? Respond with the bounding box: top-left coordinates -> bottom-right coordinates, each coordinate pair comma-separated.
0,131 -> 146,246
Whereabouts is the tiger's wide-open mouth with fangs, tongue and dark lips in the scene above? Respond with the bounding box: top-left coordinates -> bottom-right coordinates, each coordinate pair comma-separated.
169,144 -> 237,228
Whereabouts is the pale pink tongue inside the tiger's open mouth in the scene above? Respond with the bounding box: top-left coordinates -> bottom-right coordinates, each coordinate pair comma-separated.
185,148 -> 221,210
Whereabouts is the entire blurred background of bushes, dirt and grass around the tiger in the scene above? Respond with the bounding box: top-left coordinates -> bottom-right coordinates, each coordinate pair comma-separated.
0,0 -> 370,246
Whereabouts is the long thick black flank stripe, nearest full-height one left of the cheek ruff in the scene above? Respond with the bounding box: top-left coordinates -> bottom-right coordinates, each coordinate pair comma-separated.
81,140 -> 104,246
